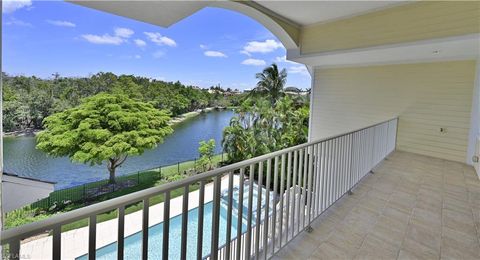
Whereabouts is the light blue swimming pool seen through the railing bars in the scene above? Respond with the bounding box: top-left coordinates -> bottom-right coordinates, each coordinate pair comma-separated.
77,182 -> 266,260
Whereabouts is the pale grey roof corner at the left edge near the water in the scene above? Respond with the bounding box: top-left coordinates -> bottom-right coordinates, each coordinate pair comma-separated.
2,172 -> 55,213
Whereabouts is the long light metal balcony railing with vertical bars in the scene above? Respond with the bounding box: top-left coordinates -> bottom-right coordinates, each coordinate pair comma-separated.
1,118 -> 398,259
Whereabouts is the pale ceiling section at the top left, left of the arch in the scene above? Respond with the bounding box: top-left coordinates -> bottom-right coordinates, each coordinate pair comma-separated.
67,0 -> 208,27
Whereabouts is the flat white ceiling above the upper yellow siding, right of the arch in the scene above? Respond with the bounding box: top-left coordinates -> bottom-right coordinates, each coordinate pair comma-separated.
255,0 -> 408,26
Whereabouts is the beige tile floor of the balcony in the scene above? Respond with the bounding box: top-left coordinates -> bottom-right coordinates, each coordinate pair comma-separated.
274,151 -> 480,259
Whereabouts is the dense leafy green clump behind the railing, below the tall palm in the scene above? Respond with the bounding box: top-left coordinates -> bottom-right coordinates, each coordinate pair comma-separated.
222,96 -> 309,163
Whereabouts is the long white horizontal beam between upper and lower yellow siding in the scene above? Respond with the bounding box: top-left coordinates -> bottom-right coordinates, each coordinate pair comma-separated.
287,34 -> 480,68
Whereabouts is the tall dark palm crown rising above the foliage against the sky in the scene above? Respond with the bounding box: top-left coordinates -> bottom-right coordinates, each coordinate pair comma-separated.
252,63 -> 287,105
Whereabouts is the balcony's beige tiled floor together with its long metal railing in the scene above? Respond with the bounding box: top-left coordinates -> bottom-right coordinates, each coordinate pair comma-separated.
2,118 -> 480,259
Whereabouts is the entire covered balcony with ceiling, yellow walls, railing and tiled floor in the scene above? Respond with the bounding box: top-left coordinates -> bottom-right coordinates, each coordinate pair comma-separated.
1,0 -> 480,259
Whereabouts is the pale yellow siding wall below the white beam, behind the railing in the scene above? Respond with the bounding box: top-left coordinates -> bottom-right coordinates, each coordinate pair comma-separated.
311,61 -> 475,162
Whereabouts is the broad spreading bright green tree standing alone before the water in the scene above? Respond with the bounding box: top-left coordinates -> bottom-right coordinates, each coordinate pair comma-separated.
37,93 -> 173,184
